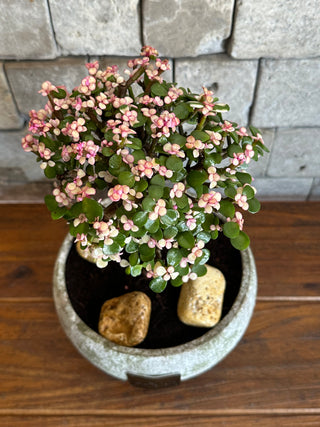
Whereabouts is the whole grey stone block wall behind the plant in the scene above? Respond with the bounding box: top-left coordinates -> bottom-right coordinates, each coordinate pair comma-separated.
0,0 -> 320,201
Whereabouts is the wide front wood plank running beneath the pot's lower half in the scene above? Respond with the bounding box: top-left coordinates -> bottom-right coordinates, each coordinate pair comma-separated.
0,301 -> 320,416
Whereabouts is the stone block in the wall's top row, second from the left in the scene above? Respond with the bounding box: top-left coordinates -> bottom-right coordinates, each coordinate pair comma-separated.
49,0 -> 141,55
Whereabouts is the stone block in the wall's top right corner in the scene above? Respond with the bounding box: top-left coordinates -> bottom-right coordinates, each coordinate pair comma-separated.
229,0 -> 320,58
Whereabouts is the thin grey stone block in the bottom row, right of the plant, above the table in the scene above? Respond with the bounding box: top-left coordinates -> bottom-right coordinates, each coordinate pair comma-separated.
253,178 -> 312,201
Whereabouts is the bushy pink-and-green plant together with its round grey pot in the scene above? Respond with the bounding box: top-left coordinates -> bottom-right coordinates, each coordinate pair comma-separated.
22,46 -> 268,385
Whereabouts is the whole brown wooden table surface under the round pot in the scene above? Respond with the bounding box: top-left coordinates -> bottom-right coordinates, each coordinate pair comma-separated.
0,202 -> 320,427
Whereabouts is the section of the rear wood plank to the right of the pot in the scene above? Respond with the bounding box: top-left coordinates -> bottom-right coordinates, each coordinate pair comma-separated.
246,202 -> 320,296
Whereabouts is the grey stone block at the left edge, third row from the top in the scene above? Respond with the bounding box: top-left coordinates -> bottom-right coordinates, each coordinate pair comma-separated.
0,129 -> 47,182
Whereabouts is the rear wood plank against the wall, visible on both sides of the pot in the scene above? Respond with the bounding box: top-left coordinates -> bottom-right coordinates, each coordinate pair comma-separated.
0,202 -> 320,298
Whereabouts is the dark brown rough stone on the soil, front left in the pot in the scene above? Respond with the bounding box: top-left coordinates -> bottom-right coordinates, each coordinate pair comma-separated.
99,291 -> 151,347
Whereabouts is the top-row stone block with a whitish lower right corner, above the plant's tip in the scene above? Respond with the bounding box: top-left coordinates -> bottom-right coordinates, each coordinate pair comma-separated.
143,0 -> 234,57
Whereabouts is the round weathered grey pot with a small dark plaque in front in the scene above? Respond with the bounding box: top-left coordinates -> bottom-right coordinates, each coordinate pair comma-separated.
53,235 -> 257,387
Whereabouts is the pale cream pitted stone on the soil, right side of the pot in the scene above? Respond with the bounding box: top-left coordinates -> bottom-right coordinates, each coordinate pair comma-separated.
178,265 -> 226,328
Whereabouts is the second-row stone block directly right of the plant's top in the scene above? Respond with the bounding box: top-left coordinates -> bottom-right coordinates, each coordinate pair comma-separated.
175,55 -> 258,127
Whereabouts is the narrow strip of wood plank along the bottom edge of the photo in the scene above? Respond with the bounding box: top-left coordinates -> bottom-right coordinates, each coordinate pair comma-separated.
0,414 -> 320,427
